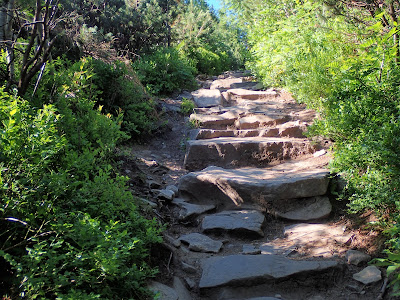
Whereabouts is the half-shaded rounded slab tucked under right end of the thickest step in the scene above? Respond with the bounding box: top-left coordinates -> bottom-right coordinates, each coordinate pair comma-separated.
275,197 -> 332,221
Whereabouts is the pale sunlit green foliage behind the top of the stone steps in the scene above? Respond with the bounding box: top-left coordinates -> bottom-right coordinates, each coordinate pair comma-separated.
173,1 -> 245,75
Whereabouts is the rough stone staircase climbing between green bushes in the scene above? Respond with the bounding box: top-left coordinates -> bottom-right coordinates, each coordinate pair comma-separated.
151,73 -> 384,300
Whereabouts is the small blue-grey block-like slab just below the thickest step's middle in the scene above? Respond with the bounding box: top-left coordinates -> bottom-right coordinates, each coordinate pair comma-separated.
201,210 -> 265,236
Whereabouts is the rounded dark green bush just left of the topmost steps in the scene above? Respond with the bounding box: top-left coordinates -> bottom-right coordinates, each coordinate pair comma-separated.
133,48 -> 196,95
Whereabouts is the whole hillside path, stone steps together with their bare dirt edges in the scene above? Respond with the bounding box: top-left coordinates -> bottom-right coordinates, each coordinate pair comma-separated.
126,72 -> 389,300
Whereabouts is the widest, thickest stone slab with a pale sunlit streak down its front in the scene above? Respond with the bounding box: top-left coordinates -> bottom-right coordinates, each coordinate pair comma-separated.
179,164 -> 329,207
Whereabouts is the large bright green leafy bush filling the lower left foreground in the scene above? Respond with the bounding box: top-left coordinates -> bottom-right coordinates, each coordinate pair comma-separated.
0,83 -> 160,299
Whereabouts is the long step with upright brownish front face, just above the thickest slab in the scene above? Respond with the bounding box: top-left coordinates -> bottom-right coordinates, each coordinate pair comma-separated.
184,137 -> 315,171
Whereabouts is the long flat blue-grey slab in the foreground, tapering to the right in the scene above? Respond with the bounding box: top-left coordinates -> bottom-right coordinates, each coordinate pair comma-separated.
199,255 -> 338,289
